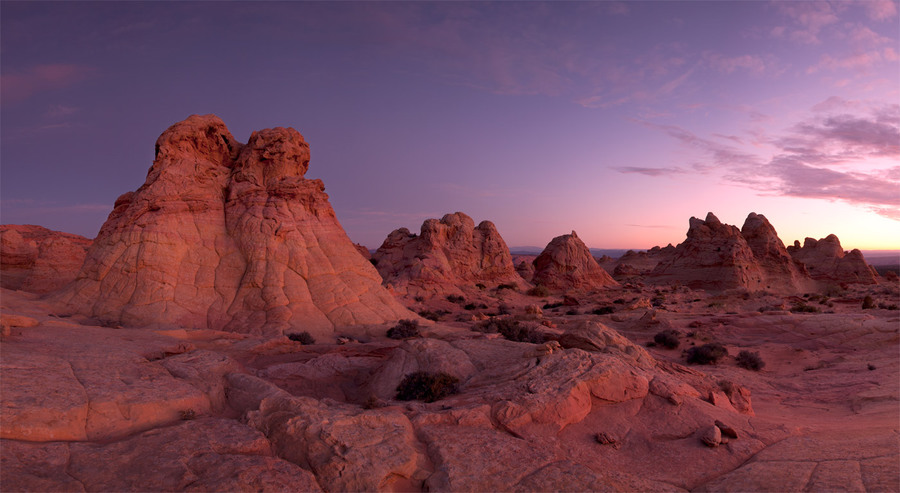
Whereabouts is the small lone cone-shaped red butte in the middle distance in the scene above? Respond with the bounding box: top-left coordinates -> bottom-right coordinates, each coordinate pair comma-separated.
532,231 -> 619,290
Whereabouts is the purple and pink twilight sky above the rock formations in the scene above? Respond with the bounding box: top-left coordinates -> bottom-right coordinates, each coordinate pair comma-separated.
0,0 -> 900,249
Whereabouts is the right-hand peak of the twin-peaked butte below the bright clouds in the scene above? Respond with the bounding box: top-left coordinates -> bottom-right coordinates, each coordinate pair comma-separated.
741,212 -> 812,292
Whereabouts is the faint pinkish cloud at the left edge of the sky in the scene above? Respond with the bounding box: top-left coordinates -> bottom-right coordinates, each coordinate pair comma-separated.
0,63 -> 94,104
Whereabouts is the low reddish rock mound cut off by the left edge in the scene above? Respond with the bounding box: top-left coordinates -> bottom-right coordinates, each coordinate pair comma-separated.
0,224 -> 91,294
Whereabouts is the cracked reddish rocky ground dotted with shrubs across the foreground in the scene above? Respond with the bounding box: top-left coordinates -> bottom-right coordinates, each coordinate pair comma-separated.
0,278 -> 900,491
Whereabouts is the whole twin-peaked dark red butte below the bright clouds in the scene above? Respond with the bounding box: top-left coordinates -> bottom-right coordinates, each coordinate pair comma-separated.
649,212 -> 811,292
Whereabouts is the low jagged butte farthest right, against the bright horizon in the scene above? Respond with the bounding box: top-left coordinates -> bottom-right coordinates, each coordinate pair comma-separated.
787,235 -> 878,284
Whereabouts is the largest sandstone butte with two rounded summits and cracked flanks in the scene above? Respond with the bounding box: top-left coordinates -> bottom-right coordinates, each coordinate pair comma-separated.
54,115 -> 411,335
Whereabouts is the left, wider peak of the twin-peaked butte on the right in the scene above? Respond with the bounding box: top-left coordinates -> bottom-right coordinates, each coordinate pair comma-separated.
650,212 -> 765,290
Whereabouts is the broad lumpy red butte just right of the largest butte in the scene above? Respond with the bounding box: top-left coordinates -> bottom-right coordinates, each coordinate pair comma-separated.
372,212 -> 523,293
